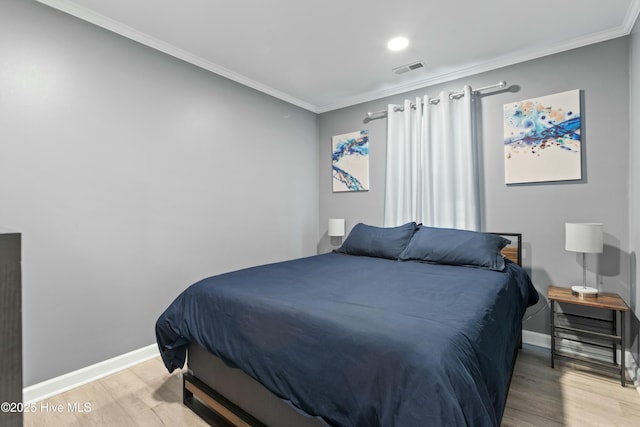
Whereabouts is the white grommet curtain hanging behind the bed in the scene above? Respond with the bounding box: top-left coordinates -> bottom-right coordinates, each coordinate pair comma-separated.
384,86 -> 480,230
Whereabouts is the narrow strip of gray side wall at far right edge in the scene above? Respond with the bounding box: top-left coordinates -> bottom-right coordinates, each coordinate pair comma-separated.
629,20 -> 640,368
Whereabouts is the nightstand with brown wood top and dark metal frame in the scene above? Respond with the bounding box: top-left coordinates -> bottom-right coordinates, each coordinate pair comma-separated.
547,286 -> 629,387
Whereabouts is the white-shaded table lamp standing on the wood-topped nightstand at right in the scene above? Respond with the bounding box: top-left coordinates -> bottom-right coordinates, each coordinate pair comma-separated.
565,222 -> 603,297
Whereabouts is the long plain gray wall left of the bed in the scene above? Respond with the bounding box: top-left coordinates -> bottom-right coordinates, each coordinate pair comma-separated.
0,0 -> 318,386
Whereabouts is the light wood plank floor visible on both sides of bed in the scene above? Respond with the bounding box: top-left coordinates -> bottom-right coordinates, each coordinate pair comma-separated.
24,348 -> 640,427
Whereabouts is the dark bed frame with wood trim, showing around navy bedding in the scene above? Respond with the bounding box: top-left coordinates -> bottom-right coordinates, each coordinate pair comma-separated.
182,233 -> 522,427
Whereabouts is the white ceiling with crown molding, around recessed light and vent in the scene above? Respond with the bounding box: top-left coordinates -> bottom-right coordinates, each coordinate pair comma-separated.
38,0 -> 640,113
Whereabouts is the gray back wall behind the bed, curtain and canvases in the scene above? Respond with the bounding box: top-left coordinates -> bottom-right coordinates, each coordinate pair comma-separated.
318,38 -> 630,333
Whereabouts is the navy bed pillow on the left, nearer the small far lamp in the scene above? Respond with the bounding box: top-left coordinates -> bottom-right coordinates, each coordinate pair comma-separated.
336,222 -> 418,259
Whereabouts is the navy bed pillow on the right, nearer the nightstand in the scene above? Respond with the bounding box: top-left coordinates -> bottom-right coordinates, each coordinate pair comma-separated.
398,226 -> 511,271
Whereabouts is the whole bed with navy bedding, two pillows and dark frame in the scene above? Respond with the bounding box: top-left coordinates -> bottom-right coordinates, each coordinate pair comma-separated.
156,223 -> 538,427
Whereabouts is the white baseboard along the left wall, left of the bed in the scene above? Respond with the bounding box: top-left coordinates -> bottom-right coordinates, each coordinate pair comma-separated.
22,344 -> 160,403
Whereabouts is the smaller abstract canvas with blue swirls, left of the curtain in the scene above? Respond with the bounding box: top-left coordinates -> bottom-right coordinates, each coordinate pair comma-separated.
331,130 -> 369,192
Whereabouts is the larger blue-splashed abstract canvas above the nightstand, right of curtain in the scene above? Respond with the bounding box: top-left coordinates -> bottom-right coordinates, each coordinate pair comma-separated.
504,89 -> 582,184
